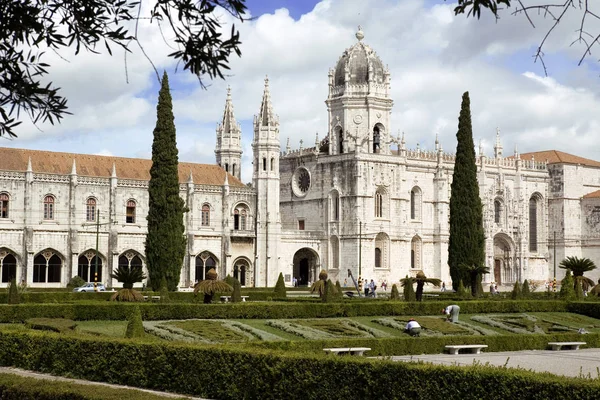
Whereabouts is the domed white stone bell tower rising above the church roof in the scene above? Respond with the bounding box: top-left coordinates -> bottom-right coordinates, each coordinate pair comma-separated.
325,26 -> 393,155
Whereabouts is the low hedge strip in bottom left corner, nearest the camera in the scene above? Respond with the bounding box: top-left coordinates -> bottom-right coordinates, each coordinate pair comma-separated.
0,373 -> 187,400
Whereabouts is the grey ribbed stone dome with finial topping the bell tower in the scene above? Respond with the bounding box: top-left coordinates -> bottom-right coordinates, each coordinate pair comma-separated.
333,26 -> 385,86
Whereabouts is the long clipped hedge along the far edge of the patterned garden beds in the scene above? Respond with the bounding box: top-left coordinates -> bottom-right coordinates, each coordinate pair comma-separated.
0,300 -> 572,322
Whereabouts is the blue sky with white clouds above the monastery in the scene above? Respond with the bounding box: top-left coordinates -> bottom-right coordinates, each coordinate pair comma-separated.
0,0 -> 600,182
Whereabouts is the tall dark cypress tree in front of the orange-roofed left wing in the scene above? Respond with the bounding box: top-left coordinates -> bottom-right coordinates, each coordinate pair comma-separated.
146,72 -> 186,291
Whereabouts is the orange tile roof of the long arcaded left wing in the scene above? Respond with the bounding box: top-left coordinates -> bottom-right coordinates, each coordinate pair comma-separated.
0,147 -> 245,187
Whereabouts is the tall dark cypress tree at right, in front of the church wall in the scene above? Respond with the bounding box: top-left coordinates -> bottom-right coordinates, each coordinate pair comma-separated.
448,92 -> 485,290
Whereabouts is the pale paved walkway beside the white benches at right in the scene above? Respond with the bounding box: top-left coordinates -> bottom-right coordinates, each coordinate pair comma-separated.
391,349 -> 600,378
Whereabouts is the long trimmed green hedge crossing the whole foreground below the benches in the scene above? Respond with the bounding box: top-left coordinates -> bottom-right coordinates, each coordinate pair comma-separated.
0,333 -> 600,400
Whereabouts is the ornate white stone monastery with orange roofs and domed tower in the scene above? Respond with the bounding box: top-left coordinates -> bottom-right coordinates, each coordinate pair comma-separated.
0,31 -> 600,287
